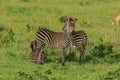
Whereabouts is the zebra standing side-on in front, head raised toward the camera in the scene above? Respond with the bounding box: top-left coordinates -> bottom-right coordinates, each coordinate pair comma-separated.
35,17 -> 76,65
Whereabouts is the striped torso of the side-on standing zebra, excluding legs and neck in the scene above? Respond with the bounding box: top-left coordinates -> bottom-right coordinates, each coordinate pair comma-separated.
36,28 -> 67,48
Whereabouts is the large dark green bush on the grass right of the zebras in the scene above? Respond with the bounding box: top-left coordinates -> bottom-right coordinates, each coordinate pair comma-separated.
82,40 -> 120,64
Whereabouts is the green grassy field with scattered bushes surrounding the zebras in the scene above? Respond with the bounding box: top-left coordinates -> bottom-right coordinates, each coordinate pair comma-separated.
0,0 -> 120,80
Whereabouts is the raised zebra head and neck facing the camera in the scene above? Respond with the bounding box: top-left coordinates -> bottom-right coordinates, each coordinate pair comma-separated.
62,17 -> 77,36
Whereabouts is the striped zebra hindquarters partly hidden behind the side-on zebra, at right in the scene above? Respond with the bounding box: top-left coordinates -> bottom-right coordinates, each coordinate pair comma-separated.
70,30 -> 87,60
